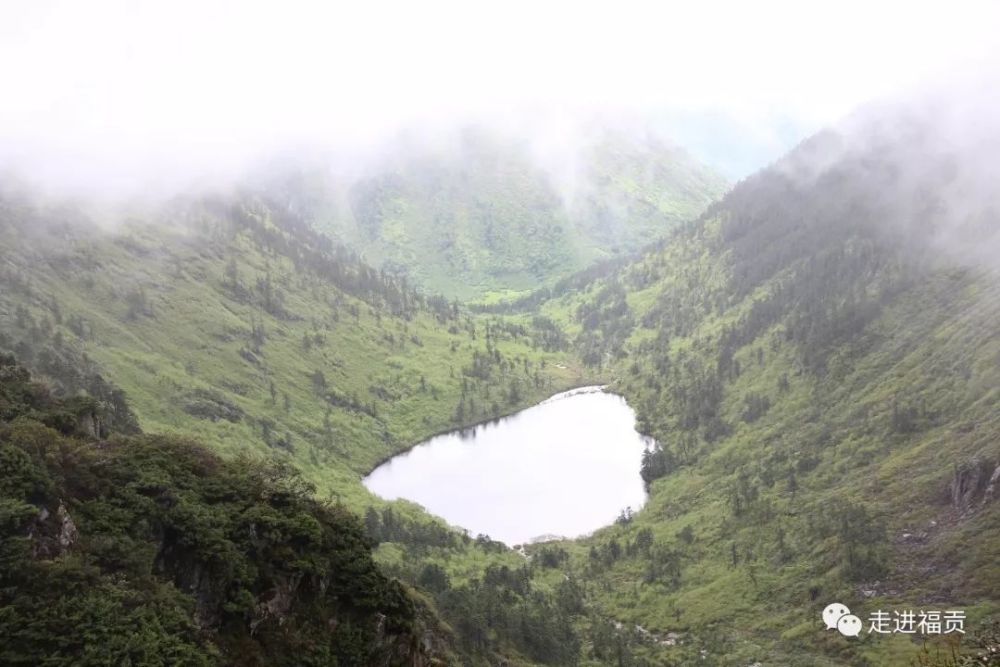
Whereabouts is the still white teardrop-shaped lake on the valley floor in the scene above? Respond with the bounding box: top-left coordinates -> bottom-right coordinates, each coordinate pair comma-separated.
364,387 -> 652,545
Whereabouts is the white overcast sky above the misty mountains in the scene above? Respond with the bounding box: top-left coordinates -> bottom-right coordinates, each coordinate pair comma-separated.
0,0 -> 1000,192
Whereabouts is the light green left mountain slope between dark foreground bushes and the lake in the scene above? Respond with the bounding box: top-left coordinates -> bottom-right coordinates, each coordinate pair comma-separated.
0,192 -> 576,487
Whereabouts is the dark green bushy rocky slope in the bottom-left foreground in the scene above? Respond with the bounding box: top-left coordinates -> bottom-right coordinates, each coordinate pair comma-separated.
0,356 -> 437,666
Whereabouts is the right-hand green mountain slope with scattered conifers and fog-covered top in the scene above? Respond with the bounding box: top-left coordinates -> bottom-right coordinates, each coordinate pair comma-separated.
515,98 -> 1000,665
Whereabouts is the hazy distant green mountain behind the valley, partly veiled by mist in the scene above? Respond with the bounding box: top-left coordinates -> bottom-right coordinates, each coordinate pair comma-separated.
258,128 -> 726,298
